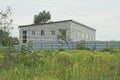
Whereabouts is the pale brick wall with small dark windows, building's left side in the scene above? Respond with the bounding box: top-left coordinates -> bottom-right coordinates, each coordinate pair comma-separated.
19,22 -> 70,44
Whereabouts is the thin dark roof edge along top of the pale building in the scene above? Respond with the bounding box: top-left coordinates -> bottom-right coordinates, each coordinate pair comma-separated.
18,20 -> 96,31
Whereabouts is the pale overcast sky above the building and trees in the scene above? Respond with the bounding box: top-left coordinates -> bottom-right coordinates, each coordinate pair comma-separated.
0,0 -> 120,41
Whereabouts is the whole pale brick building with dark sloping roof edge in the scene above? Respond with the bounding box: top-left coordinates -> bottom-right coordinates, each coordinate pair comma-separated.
19,20 -> 96,44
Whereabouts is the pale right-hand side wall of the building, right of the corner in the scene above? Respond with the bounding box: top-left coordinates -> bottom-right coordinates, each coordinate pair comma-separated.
71,22 -> 95,41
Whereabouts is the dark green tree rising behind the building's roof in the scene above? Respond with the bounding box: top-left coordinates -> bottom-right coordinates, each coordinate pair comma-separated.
34,10 -> 51,24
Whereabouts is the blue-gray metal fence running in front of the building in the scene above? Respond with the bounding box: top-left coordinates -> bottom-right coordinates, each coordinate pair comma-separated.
15,41 -> 120,50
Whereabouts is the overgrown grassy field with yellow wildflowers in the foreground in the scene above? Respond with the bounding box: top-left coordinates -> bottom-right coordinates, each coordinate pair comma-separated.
0,50 -> 120,80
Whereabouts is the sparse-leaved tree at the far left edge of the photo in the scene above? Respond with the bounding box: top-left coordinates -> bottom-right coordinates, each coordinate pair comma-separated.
0,7 -> 13,46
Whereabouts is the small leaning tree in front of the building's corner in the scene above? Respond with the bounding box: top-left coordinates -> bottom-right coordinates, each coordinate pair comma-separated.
57,28 -> 70,49
